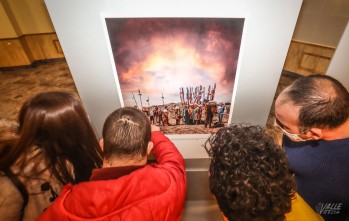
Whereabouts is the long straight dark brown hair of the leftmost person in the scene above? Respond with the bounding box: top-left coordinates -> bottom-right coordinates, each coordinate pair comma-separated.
1,92 -> 102,183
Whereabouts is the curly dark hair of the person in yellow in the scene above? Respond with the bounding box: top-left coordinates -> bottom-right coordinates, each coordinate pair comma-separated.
205,124 -> 295,221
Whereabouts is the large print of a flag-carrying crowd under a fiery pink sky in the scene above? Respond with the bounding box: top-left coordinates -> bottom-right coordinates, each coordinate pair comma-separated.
105,18 -> 244,134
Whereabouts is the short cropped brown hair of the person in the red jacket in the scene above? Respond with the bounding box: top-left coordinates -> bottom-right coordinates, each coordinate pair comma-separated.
103,107 -> 151,159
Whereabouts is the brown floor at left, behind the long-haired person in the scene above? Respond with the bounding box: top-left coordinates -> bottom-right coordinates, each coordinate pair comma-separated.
0,60 -> 77,120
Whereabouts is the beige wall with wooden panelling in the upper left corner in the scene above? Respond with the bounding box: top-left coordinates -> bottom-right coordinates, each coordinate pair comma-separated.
0,0 -> 64,67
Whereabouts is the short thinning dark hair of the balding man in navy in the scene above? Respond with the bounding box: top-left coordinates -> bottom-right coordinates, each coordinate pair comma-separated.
284,74 -> 349,129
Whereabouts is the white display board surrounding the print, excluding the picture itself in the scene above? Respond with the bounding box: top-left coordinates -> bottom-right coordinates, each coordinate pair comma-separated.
45,0 -> 302,159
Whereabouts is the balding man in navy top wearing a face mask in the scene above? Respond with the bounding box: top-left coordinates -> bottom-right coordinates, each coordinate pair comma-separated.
275,75 -> 349,221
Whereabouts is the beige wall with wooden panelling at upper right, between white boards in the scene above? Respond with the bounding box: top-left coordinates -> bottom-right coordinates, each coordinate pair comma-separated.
284,0 -> 349,75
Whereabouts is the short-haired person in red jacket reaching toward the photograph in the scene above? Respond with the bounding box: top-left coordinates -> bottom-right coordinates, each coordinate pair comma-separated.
38,107 -> 186,221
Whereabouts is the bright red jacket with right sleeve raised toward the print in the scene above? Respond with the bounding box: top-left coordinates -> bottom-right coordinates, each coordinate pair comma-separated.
38,132 -> 186,221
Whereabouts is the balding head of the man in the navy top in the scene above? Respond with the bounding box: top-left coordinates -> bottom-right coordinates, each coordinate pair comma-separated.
275,75 -> 349,141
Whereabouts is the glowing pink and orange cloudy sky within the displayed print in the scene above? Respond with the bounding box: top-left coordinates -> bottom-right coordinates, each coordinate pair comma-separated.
106,18 -> 244,106
